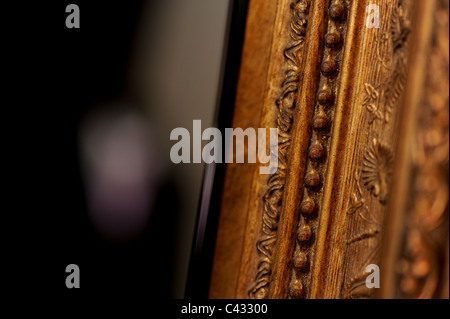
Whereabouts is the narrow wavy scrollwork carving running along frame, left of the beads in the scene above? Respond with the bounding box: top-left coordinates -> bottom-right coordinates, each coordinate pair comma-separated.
248,0 -> 309,299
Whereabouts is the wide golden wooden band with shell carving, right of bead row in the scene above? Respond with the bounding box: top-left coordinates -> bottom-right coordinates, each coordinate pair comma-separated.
314,1 -> 413,298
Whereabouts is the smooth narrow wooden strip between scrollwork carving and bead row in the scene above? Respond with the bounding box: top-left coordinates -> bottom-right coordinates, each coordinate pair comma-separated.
269,1 -> 326,298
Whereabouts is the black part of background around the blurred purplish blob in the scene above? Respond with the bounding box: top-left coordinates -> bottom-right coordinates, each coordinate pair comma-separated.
1,1 -> 177,298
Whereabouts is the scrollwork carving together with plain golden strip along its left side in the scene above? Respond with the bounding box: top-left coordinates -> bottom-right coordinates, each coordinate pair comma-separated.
237,0 -> 304,298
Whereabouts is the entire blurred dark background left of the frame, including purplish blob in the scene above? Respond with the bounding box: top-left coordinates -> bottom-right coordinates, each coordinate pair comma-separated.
3,0 -> 229,298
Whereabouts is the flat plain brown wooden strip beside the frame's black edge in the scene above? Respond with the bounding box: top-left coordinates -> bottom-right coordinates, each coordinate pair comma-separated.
209,0 -> 276,298
